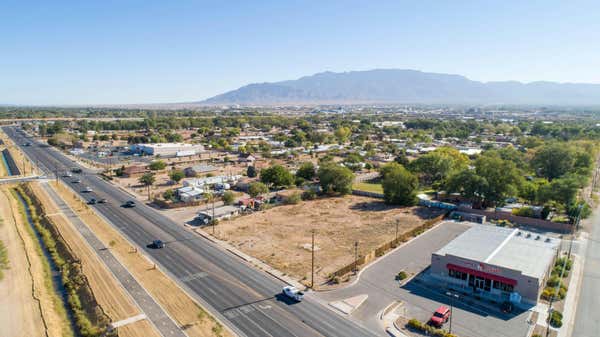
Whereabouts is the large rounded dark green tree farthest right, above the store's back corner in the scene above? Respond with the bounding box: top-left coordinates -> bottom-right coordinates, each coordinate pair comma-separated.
531,143 -> 575,181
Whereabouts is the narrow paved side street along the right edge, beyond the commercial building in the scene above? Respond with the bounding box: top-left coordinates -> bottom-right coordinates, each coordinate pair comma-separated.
572,211 -> 600,337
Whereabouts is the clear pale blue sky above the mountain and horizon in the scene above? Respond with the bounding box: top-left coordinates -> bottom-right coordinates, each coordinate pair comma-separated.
0,0 -> 600,104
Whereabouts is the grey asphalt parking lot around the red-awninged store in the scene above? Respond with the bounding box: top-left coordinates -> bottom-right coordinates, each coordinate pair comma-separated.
314,221 -> 529,337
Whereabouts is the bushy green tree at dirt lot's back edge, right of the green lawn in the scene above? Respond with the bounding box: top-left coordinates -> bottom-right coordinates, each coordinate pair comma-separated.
381,163 -> 419,206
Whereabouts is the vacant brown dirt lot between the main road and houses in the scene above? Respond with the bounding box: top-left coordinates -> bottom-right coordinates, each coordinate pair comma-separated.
209,196 -> 441,285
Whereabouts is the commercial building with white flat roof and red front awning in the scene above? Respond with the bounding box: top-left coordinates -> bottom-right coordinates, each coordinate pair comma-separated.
430,224 -> 559,307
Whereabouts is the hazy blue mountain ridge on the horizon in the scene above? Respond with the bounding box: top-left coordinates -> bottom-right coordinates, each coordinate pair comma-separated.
199,69 -> 600,105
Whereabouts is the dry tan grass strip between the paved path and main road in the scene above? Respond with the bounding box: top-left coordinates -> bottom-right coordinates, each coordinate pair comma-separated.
51,183 -> 231,337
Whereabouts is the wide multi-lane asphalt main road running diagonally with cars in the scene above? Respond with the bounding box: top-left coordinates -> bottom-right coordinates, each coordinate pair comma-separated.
4,127 -> 377,337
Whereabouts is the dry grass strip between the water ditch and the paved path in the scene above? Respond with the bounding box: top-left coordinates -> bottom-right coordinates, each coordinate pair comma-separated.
31,184 -> 159,337
